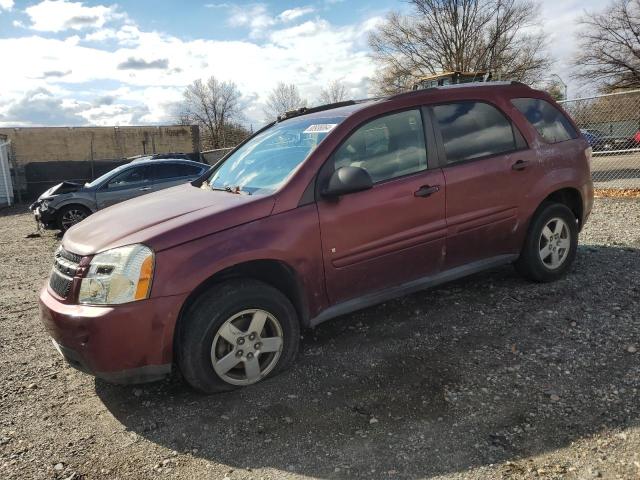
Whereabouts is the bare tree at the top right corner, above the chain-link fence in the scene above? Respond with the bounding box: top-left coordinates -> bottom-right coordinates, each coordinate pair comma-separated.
574,0 -> 640,91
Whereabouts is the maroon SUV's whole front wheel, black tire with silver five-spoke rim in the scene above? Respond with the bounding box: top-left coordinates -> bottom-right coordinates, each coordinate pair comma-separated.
176,279 -> 300,393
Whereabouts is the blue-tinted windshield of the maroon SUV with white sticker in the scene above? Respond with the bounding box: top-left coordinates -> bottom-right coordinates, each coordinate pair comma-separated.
208,116 -> 345,194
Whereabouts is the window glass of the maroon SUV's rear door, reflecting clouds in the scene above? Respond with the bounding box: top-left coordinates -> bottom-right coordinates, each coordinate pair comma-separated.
433,102 -> 518,163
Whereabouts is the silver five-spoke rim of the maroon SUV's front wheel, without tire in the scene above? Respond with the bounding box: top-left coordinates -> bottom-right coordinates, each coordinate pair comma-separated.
211,309 -> 283,385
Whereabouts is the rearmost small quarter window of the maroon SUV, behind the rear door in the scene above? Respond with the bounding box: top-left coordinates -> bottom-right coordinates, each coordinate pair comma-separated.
511,98 -> 578,143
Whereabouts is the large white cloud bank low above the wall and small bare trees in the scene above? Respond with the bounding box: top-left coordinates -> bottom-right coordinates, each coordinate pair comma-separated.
0,12 -> 375,127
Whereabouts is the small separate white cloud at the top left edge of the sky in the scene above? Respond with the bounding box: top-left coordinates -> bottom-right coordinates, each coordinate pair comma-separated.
24,0 -> 126,32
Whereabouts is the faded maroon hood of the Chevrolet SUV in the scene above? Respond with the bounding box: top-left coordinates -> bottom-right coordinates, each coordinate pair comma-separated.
62,184 -> 275,255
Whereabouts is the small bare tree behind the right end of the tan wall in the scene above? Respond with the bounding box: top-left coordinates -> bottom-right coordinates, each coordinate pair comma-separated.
179,77 -> 242,148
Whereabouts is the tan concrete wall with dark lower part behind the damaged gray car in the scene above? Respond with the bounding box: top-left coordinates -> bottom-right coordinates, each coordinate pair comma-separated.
0,125 -> 200,200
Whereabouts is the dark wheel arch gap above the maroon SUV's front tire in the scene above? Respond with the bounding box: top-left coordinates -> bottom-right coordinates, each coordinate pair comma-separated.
173,259 -> 309,351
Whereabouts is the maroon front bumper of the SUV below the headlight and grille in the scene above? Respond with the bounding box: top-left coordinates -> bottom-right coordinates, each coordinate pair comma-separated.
39,287 -> 186,383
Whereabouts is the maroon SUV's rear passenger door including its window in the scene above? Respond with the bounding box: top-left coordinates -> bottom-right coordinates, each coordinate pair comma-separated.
430,101 -> 539,269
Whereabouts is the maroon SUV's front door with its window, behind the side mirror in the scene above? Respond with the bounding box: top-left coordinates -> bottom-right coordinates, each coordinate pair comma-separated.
318,109 -> 446,304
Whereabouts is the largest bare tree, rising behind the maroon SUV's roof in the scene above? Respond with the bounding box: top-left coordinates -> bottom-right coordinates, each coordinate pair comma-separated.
369,0 -> 551,93
